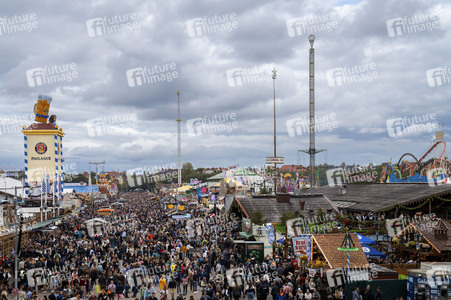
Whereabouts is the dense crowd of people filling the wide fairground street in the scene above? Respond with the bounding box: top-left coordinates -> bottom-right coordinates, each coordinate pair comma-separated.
0,192 -> 381,300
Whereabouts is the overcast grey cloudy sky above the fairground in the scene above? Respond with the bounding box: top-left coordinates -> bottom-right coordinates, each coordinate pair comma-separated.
0,0 -> 451,171
